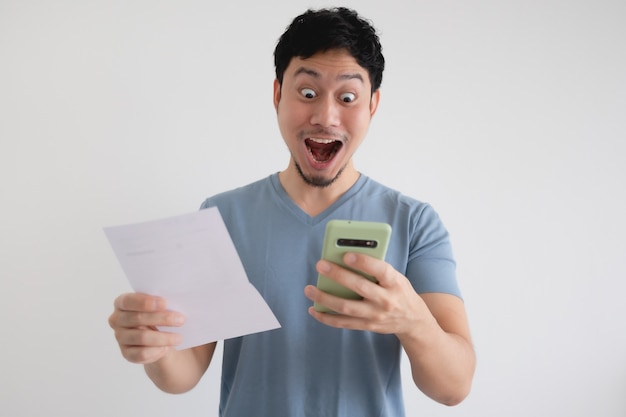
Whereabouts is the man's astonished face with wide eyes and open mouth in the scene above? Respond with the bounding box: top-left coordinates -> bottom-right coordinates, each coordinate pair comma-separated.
274,50 -> 379,187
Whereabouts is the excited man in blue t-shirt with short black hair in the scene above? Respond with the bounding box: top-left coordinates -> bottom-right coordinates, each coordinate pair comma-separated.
109,8 -> 475,417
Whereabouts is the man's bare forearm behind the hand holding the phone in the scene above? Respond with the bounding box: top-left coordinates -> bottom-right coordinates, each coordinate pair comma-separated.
398,319 -> 476,405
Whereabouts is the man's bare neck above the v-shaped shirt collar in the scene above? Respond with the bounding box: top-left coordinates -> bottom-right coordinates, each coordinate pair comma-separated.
278,161 -> 360,217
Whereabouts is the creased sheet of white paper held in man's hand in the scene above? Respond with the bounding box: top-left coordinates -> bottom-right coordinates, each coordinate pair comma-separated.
104,208 -> 280,349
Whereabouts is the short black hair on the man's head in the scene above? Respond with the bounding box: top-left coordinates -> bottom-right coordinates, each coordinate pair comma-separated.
274,7 -> 385,92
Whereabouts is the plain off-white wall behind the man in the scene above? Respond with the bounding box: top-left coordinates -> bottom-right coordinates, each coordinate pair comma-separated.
0,0 -> 626,417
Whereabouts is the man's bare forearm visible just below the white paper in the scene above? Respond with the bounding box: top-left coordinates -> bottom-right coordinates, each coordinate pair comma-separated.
144,343 -> 216,394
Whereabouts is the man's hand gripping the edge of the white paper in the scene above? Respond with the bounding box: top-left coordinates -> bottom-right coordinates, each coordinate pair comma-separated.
109,293 -> 185,364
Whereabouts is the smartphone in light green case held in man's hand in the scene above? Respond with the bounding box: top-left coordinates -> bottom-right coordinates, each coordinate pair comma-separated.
314,220 -> 391,312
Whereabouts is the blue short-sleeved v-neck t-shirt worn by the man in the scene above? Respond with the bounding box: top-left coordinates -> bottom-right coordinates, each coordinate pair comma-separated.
202,174 -> 460,417
